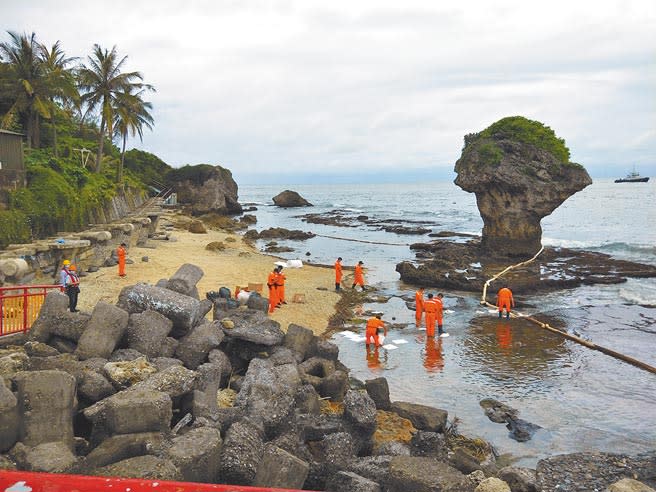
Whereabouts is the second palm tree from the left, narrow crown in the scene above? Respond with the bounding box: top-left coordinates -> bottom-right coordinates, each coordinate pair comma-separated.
39,41 -> 80,157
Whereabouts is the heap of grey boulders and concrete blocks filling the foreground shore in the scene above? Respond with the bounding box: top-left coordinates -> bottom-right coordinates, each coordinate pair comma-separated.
0,264 -> 656,492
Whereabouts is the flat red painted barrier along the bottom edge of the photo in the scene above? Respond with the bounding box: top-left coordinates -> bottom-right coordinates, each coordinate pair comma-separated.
0,470 -> 308,492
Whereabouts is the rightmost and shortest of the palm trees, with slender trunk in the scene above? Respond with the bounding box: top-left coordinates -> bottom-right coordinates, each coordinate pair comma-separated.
114,86 -> 155,184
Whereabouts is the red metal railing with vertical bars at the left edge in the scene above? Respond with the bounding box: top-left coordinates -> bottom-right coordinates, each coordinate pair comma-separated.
0,285 -> 64,336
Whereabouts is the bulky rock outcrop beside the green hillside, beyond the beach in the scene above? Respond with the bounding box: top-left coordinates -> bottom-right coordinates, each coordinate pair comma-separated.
168,164 -> 242,215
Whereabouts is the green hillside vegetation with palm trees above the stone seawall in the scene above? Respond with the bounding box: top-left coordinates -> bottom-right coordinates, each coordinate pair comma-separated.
0,32 -> 158,248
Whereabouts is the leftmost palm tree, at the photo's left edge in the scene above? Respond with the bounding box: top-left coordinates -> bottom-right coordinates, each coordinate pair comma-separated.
0,31 -> 50,147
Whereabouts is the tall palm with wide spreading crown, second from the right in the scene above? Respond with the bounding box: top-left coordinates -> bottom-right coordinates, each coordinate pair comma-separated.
78,44 -> 150,173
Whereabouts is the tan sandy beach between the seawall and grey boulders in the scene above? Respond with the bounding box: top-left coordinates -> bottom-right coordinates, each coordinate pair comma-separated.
78,214 -> 340,335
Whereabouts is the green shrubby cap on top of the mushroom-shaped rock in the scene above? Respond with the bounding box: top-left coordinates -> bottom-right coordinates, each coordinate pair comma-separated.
478,116 -> 570,164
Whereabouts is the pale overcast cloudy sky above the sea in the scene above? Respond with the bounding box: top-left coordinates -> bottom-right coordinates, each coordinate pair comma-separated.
0,0 -> 656,184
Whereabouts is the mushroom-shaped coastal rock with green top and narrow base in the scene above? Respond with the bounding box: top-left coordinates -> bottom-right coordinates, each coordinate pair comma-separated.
455,116 -> 592,257
